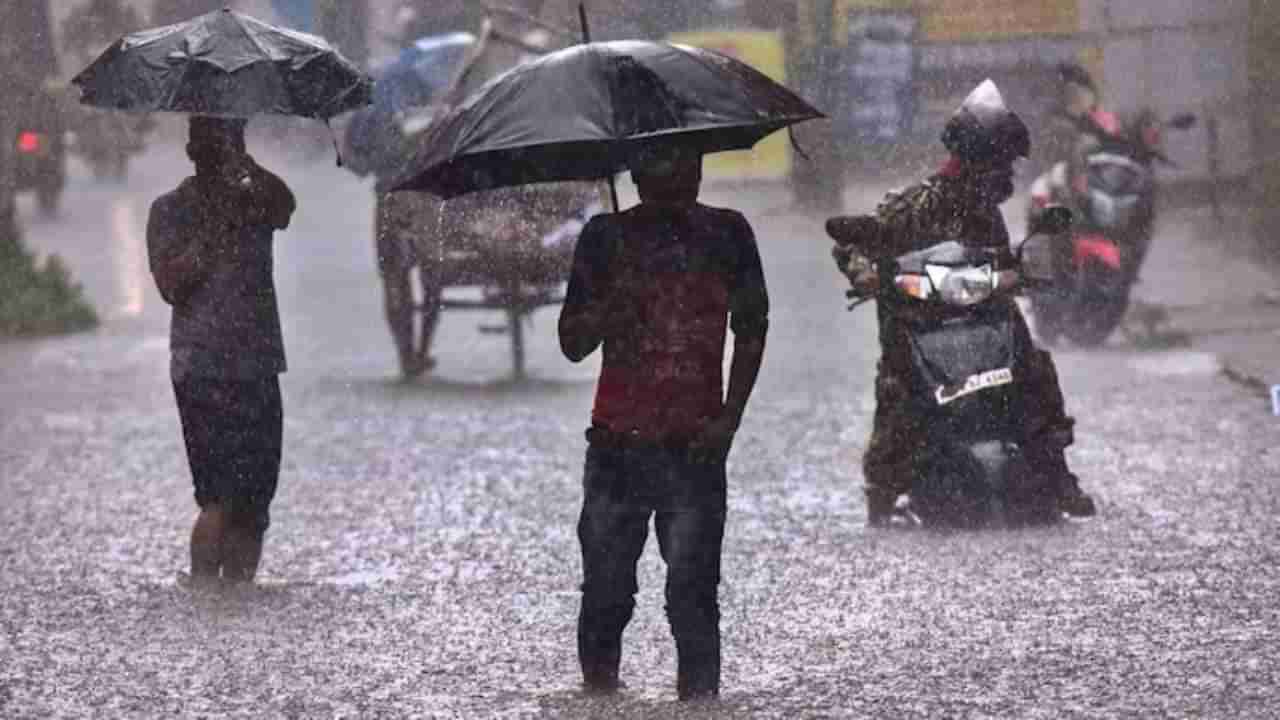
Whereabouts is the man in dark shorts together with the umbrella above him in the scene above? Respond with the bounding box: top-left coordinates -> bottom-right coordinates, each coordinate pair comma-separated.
72,9 -> 372,585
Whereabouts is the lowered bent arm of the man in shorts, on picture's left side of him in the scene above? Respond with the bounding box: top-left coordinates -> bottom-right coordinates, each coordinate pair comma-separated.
147,197 -> 215,305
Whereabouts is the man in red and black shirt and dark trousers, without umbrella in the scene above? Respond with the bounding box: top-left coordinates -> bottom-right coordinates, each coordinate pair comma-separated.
559,142 -> 769,700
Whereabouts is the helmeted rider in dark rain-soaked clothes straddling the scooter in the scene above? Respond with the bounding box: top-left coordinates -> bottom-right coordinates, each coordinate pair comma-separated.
827,81 -> 1096,525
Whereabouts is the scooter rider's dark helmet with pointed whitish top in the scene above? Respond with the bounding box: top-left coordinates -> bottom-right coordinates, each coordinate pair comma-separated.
942,78 -> 1032,161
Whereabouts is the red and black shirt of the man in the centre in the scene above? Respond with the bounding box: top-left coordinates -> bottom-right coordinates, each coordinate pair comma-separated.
564,199 -> 769,441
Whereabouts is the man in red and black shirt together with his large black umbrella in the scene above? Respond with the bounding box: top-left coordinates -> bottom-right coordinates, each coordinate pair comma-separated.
383,35 -> 822,700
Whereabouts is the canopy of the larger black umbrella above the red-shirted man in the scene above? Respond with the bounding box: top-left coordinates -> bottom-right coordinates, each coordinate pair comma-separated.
384,40 -> 823,197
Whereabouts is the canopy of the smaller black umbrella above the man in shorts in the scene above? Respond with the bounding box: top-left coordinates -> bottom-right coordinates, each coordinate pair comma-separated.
72,9 -> 372,119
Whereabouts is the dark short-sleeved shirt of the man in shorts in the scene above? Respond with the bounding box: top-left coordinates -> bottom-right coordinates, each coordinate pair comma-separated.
147,165 -> 293,380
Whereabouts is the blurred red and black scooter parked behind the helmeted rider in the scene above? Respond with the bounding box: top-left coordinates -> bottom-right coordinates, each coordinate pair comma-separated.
1028,111 -> 1196,347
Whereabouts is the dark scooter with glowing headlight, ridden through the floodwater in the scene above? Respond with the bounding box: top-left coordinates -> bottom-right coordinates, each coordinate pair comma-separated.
828,206 -> 1071,528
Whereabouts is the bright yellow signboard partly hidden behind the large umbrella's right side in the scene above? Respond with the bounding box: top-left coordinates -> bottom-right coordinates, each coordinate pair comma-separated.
671,31 -> 791,179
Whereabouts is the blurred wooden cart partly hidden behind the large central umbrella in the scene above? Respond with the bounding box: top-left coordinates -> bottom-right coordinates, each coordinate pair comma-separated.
375,14 -> 605,378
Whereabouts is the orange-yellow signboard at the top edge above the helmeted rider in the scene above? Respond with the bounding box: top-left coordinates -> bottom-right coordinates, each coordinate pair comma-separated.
835,0 -> 1080,42
